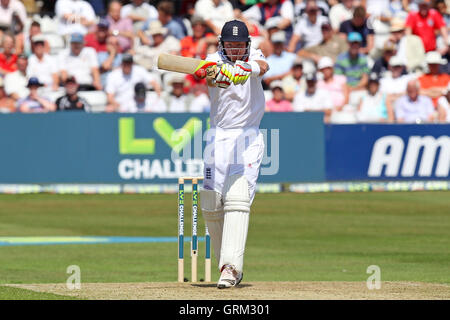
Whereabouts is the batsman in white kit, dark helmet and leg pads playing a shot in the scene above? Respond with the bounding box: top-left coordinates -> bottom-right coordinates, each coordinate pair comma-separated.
197,20 -> 269,289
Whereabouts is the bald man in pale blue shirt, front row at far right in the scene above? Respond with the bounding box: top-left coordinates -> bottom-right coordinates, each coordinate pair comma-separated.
394,80 -> 434,123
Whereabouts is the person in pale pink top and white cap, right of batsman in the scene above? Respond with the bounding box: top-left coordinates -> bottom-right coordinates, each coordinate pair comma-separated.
317,57 -> 348,111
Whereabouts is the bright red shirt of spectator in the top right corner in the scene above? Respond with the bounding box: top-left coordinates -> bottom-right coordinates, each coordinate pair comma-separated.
406,9 -> 445,52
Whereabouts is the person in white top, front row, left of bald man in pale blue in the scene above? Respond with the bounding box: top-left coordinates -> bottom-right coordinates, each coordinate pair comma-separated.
356,73 -> 394,122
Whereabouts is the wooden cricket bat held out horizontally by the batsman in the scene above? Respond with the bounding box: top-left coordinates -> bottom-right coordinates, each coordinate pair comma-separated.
158,53 -> 217,78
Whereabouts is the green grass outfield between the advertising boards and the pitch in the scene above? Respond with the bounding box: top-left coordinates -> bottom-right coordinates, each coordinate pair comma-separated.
0,192 -> 450,299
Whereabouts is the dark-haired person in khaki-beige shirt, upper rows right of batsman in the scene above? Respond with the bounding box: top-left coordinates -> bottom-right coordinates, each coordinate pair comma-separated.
297,22 -> 348,64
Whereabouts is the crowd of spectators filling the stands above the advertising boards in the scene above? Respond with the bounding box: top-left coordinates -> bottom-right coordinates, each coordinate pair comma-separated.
0,0 -> 450,123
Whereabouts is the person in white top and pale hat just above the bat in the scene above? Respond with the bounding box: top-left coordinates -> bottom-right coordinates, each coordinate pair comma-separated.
135,20 -> 181,70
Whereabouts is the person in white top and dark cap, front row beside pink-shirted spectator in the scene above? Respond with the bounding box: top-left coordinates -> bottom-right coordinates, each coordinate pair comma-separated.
292,73 -> 333,122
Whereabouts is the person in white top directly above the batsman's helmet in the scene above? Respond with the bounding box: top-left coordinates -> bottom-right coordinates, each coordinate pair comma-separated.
195,0 -> 234,35
